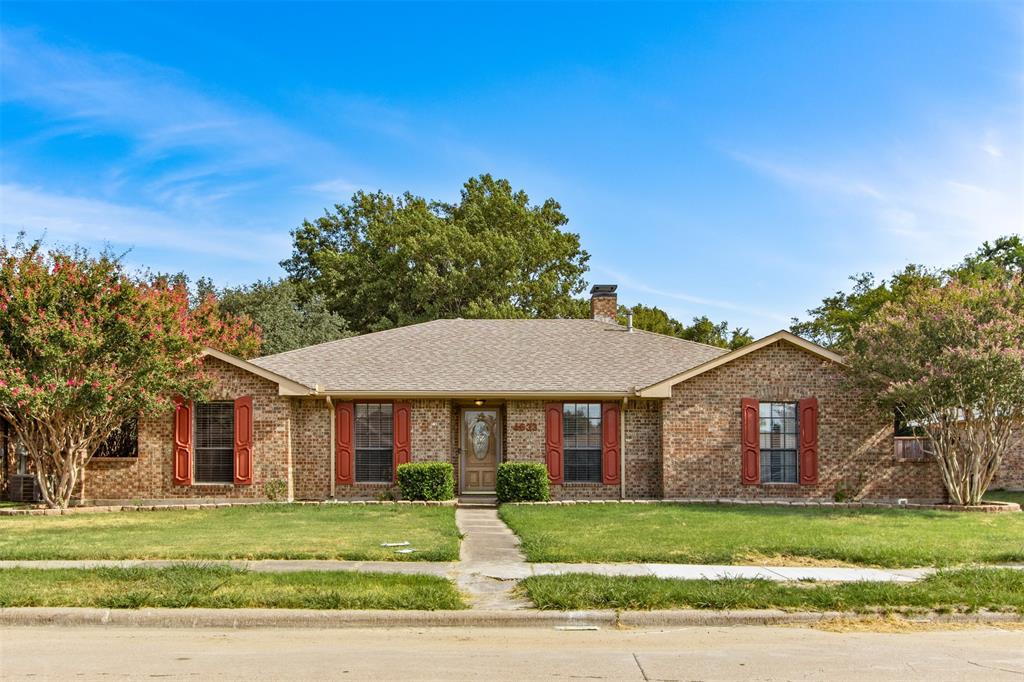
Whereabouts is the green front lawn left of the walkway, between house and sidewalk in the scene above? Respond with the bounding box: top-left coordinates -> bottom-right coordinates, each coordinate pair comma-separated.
0,505 -> 459,561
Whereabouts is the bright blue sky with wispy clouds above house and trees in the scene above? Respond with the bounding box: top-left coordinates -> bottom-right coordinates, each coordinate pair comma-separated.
0,2 -> 1024,335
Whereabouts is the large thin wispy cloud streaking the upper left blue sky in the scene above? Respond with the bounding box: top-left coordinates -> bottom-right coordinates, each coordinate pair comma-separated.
0,27 -> 343,210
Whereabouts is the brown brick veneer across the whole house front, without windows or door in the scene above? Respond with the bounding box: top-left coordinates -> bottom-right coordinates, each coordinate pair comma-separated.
39,341 -> 991,501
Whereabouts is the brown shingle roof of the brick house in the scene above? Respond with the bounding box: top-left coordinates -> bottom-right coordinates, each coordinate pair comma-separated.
252,319 -> 726,395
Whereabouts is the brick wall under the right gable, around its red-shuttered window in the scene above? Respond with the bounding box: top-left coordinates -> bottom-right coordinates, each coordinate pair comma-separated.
662,341 -> 945,500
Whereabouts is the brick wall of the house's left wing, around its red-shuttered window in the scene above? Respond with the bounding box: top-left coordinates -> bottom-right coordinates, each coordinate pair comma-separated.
82,357 -> 293,500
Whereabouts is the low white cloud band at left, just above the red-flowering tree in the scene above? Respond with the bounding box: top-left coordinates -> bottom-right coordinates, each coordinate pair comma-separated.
0,184 -> 289,263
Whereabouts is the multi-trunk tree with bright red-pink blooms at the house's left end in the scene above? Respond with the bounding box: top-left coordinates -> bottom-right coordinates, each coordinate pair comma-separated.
0,240 -> 259,508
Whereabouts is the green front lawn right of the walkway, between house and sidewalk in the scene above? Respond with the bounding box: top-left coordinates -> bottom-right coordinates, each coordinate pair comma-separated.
500,505 -> 1024,566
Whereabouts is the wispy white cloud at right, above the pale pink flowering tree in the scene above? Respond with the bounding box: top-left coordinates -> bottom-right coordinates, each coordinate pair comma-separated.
728,124 -> 1024,263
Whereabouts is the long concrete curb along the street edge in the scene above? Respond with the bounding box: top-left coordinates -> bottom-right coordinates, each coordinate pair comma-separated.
0,607 -> 1024,629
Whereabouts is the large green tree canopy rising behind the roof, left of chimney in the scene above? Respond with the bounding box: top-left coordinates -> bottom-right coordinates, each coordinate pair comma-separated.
282,175 -> 589,333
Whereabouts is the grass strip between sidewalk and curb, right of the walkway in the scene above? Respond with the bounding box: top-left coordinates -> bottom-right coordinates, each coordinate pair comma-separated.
520,568 -> 1024,612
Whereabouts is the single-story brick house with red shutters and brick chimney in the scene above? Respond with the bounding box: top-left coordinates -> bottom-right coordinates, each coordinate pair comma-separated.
0,286 -> 1024,503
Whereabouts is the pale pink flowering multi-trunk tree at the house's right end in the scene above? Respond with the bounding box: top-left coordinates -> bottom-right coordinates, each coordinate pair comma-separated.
849,275 -> 1024,505
